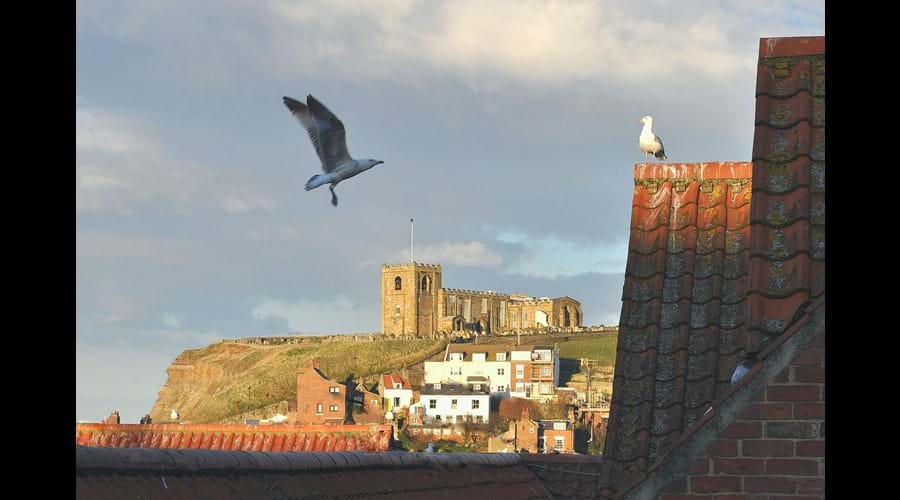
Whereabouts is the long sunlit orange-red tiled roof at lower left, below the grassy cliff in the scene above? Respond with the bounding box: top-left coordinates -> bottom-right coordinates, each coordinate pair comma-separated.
75,424 -> 392,451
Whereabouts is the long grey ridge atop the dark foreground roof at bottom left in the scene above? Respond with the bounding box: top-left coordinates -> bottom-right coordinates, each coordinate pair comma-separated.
75,446 -> 522,472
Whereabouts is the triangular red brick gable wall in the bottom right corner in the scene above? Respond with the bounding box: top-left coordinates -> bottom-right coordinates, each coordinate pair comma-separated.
659,334 -> 825,500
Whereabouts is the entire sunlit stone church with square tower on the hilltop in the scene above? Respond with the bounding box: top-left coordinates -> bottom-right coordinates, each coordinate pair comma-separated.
381,262 -> 583,337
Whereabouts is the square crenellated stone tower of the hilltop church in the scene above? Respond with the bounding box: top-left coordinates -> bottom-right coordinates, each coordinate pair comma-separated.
381,262 -> 441,337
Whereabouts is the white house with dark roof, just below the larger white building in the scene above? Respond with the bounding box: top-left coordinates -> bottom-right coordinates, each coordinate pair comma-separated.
417,383 -> 491,424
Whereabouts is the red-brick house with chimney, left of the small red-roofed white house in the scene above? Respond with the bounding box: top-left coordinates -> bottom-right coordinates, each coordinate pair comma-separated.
291,360 -> 347,425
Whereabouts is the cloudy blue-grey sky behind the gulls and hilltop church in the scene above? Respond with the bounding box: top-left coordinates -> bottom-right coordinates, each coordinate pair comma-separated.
75,0 -> 825,422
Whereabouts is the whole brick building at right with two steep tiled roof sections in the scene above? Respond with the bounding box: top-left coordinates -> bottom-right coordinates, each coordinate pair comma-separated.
598,37 -> 825,500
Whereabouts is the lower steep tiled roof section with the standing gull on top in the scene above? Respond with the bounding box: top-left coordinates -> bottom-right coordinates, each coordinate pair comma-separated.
603,162 -> 752,490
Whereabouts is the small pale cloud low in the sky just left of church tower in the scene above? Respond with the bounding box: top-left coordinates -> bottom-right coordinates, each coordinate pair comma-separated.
251,295 -> 380,334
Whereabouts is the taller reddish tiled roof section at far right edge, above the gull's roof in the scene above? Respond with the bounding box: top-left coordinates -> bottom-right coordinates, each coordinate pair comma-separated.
747,37 -> 825,352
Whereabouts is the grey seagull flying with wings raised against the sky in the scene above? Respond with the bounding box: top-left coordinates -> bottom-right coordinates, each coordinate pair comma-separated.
284,95 -> 384,206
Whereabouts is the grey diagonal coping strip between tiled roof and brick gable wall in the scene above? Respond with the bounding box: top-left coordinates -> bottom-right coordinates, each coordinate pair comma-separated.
612,295 -> 825,498
